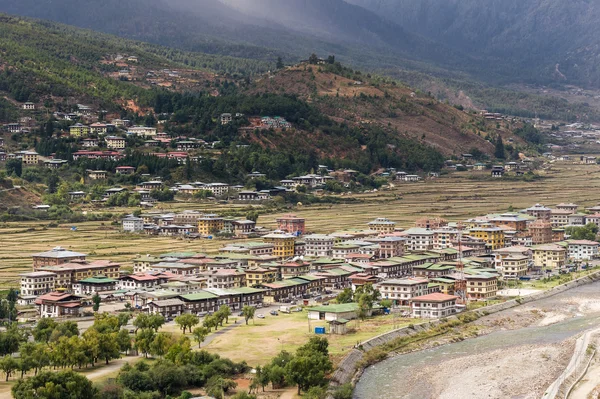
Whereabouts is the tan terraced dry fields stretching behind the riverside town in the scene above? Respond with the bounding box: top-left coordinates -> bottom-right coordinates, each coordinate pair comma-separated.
0,163 -> 600,288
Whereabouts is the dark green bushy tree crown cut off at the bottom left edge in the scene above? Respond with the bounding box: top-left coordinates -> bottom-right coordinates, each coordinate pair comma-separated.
12,370 -> 98,399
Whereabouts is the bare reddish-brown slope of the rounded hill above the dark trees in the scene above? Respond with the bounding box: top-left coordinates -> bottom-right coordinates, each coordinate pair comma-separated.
245,66 -> 525,155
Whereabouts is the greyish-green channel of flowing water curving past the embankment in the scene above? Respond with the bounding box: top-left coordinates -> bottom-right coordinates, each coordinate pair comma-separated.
354,282 -> 600,399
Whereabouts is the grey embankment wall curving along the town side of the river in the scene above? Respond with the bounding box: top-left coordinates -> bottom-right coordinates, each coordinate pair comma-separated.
328,272 -> 600,399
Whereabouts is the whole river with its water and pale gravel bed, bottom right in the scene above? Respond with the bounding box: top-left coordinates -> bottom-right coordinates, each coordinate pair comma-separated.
354,282 -> 600,399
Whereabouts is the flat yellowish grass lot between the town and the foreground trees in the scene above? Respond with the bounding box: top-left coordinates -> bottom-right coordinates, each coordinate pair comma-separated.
203,311 -> 415,366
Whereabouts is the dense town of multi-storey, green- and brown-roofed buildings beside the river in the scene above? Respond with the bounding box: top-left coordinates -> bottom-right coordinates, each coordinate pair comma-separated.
19,203 -> 600,334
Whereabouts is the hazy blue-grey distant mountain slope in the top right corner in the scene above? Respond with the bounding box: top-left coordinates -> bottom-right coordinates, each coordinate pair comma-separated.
347,0 -> 600,87
